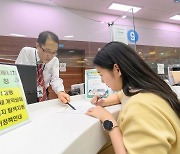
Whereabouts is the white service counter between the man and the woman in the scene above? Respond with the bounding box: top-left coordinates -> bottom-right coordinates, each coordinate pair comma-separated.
0,95 -> 121,154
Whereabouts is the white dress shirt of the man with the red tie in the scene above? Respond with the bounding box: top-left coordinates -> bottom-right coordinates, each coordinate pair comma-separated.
15,47 -> 64,94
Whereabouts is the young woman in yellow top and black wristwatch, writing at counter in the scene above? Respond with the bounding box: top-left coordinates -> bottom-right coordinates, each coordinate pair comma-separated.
87,42 -> 180,154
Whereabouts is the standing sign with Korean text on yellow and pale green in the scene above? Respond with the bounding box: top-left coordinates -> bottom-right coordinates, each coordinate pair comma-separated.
0,64 -> 30,135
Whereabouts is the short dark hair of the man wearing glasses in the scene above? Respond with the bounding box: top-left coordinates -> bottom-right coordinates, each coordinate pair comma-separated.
37,31 -> 59,45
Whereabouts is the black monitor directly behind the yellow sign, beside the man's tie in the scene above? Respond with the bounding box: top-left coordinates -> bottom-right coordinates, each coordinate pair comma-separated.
0,64 -> 37,104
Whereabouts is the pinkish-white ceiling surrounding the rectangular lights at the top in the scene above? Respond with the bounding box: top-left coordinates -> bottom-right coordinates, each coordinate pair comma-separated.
23,0 -> 180,24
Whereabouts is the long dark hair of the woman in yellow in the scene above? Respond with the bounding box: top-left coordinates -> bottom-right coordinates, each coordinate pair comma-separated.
93,42 -> 180,117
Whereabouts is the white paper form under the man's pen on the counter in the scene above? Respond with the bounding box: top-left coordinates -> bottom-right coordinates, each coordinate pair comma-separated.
58,100 -> 95,114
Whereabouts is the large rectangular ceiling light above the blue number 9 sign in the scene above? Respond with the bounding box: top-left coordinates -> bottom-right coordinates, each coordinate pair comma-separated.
108,3 -> 141,13
